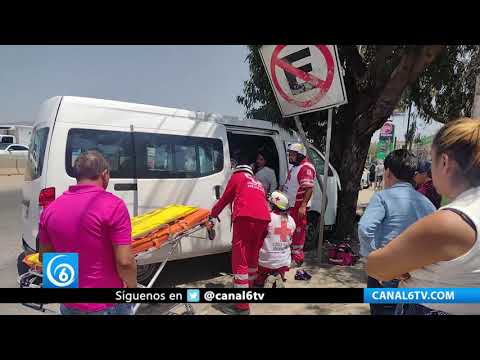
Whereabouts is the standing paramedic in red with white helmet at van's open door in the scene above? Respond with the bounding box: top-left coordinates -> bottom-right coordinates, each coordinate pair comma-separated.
283,144 -> 316,267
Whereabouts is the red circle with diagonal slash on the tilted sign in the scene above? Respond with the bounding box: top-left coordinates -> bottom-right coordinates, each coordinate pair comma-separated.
270,45 -> 335,108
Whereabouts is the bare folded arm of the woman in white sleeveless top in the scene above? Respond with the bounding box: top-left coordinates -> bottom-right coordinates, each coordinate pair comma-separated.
366,211 -> 476,281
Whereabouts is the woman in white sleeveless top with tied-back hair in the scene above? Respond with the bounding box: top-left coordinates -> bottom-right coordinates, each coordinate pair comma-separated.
367,118 -> 480,315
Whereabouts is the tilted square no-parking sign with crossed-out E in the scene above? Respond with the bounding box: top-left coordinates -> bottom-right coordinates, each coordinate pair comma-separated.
260,45 -> 347,117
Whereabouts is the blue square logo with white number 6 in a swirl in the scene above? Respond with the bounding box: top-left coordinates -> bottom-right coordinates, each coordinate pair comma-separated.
43,253 -> 78,288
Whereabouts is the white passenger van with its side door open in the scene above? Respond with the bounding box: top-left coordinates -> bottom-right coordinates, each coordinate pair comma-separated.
22,96 -> 340,280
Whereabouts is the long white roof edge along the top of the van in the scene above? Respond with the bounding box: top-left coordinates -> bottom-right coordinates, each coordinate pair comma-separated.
62,96 -> 282,129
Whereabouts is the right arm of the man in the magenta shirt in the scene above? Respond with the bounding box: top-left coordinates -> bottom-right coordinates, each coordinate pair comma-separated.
108,201 -> 137,288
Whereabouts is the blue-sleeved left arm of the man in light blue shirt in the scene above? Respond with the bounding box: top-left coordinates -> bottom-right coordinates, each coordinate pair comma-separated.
358,194 -> 385,256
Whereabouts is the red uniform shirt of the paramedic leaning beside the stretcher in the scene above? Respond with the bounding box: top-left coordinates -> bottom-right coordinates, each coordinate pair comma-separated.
211,172 -> 270,221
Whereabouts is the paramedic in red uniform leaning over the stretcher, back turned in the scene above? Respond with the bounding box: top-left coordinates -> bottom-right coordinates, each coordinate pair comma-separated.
211,154 -> 270,315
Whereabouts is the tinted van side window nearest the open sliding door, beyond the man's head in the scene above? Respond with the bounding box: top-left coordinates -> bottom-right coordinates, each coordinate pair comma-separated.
135,133 -> 223,179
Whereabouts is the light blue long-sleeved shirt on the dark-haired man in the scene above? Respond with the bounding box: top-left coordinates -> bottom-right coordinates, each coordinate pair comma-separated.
358,182 -> 436,256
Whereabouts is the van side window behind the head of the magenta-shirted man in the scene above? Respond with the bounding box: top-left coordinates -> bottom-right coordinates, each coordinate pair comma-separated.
65,129 -> 134,179
